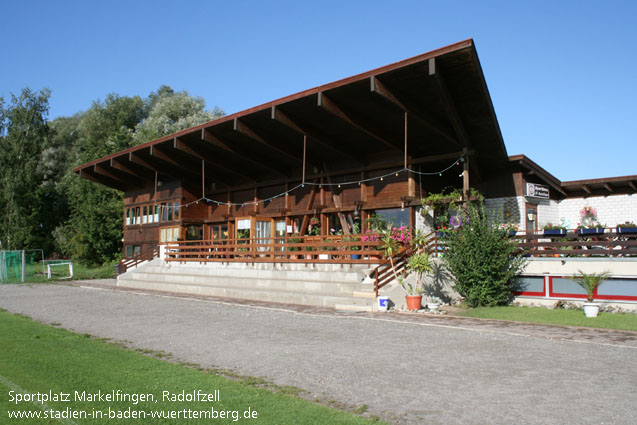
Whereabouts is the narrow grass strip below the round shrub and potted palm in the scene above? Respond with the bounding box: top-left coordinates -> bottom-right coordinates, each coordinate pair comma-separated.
454,306 -> 637,331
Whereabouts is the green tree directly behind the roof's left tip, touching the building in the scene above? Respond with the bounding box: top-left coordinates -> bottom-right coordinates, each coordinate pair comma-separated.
53,94 -> 145,265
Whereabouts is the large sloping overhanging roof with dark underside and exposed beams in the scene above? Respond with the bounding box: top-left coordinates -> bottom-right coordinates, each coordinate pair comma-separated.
74,39 -> 508,190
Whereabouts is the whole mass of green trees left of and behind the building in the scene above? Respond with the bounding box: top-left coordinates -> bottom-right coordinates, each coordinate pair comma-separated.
0,86 -> 223,264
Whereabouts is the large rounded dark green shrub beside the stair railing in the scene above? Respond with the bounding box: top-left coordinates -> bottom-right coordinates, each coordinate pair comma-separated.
443,205 -> 525,307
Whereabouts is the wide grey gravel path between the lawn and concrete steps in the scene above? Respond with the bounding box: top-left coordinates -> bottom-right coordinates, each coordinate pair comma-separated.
0,281 -> 637,424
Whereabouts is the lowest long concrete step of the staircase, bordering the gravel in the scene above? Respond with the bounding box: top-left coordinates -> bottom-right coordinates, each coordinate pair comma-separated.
117,280 -> 373,311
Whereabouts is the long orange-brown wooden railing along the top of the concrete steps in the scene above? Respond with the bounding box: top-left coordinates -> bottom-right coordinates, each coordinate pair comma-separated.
166,235 -> 382,264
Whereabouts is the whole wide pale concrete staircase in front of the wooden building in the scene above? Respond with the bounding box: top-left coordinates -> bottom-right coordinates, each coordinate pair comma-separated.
117,259 -> 376,311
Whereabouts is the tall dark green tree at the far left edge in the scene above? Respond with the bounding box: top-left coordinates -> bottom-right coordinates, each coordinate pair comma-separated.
0,88 -> 54,249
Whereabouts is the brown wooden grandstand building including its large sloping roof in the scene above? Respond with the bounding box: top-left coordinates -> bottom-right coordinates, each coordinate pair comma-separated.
75,40 -> 634,256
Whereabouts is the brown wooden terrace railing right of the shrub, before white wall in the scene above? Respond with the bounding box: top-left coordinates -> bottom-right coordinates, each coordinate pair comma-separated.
512,229 -> 637,257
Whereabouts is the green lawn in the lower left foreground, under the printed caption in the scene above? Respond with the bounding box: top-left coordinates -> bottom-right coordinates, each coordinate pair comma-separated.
0,310 -> 376,424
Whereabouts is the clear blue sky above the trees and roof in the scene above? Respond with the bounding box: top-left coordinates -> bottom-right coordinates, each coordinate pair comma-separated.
0,0 -> 637,180
